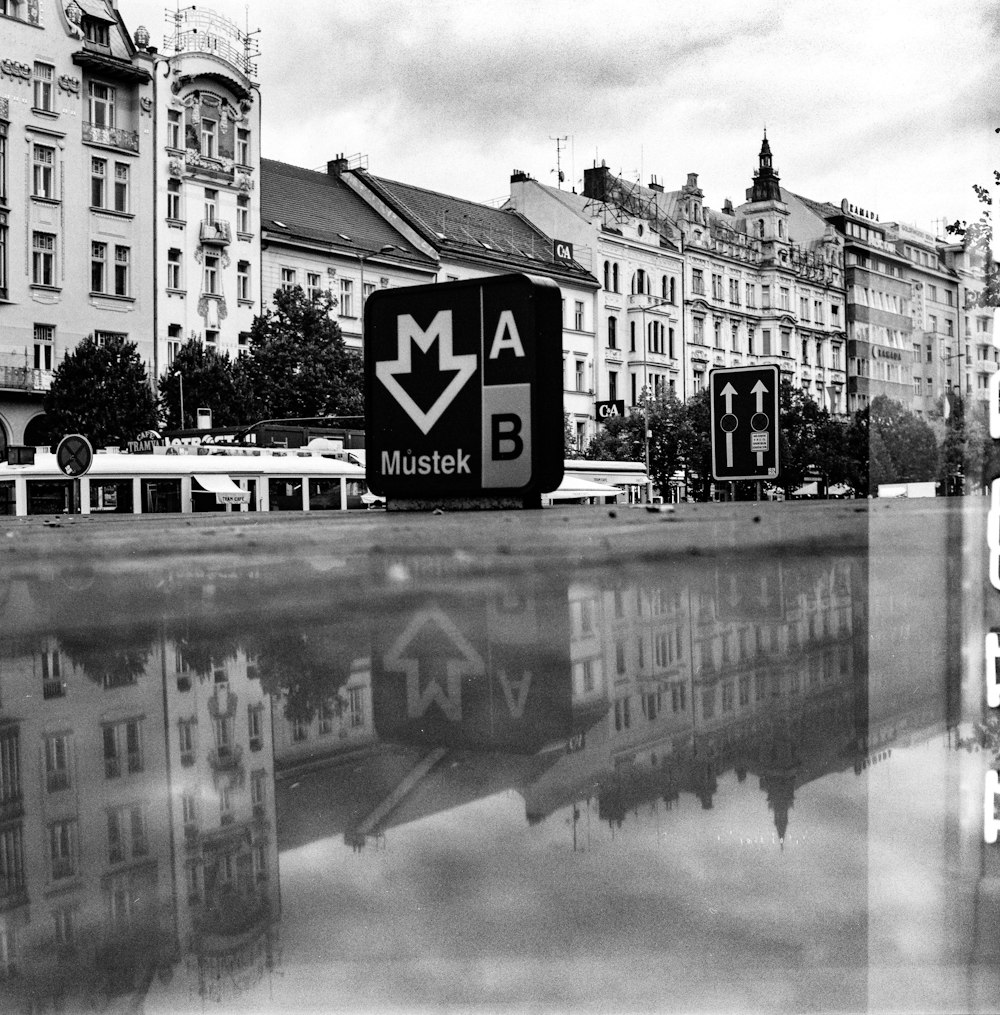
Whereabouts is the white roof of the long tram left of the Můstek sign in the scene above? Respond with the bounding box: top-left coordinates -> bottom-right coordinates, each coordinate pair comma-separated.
0,450 -> 364,481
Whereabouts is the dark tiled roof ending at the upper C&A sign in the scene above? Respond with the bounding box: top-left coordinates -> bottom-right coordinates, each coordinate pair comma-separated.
359,174 -> 596,285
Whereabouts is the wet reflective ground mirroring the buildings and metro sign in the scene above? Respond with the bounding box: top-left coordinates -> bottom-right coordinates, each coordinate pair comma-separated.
0,499 -> 1000,1013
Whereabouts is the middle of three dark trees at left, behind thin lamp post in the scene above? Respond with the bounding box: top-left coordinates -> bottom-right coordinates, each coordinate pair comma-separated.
159,339 -> 253,430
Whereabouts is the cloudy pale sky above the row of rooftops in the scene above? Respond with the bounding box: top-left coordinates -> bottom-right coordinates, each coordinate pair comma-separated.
119,0 -> 1000,232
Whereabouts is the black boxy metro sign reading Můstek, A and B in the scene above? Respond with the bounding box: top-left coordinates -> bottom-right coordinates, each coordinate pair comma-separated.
364,275 -> 563,498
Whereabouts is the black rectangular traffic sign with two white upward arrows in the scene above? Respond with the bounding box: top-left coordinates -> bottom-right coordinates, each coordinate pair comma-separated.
709,364 -> 781,480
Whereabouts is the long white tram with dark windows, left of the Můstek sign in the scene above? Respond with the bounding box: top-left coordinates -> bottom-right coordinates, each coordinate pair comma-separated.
0,445 -> 384,515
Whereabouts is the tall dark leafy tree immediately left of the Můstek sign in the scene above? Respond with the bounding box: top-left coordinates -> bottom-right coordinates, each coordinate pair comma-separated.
241,285 -> 364,419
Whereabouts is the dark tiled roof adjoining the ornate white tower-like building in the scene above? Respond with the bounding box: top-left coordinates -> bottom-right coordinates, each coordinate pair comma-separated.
261,158 -> 434,264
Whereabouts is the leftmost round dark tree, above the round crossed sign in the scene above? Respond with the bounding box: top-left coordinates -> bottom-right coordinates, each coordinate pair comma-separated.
45,335 -> 158,448
